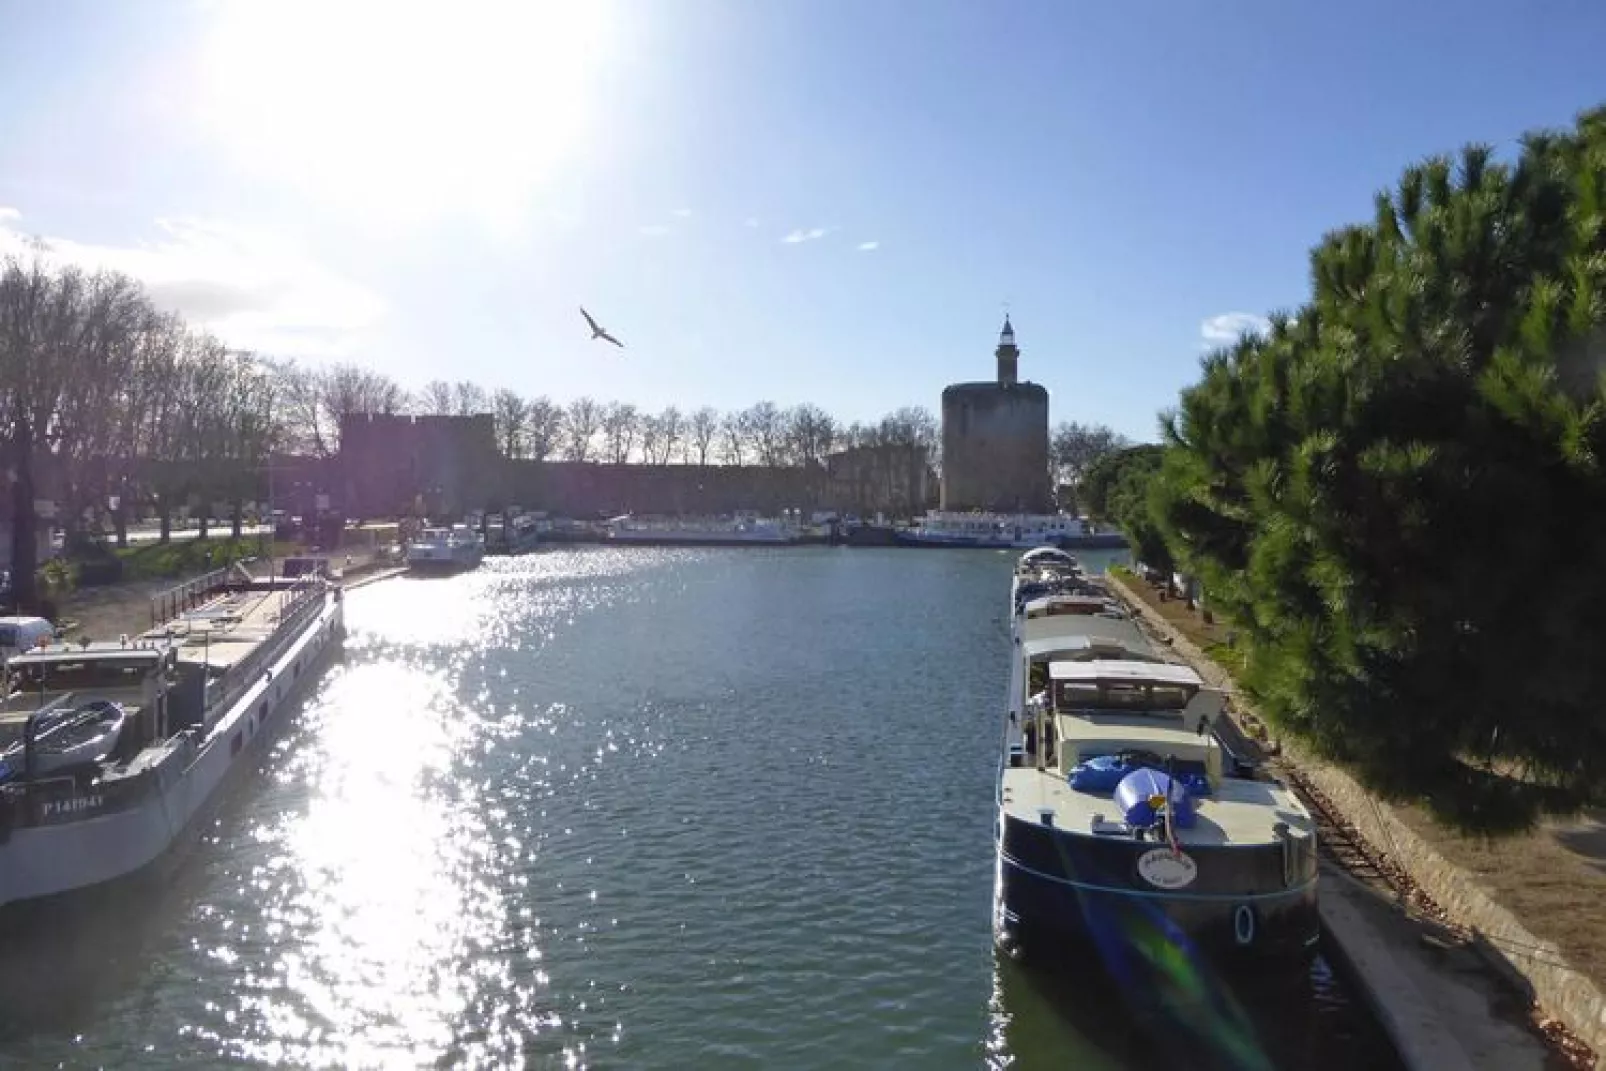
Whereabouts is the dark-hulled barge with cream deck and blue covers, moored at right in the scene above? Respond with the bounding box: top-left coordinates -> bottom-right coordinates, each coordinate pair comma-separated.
994,560 -> 1320,962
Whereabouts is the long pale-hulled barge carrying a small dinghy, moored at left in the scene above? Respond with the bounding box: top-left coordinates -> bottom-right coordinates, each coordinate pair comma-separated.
0,570 -> 344,906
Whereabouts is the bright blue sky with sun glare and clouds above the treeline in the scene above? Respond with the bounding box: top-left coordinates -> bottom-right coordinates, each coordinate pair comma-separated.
0,0 -> 1606,438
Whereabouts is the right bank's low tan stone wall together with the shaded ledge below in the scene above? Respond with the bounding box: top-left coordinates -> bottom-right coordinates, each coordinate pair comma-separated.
1108,576 -> 1606,1068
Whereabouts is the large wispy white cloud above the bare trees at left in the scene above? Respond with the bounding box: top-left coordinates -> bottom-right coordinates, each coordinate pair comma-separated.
0,209 -> 385,356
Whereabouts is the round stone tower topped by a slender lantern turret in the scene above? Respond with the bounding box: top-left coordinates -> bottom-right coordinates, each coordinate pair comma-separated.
941,316 -> 1054,514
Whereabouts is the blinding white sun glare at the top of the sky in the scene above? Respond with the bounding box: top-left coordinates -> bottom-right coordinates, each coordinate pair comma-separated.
201,0 -> 609,222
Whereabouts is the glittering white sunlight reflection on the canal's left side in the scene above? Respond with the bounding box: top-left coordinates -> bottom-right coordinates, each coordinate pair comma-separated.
194,554 -> 658,1068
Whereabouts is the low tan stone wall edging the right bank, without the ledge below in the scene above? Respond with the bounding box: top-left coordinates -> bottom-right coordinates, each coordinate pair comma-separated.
1108,576 -> 1606,1053
